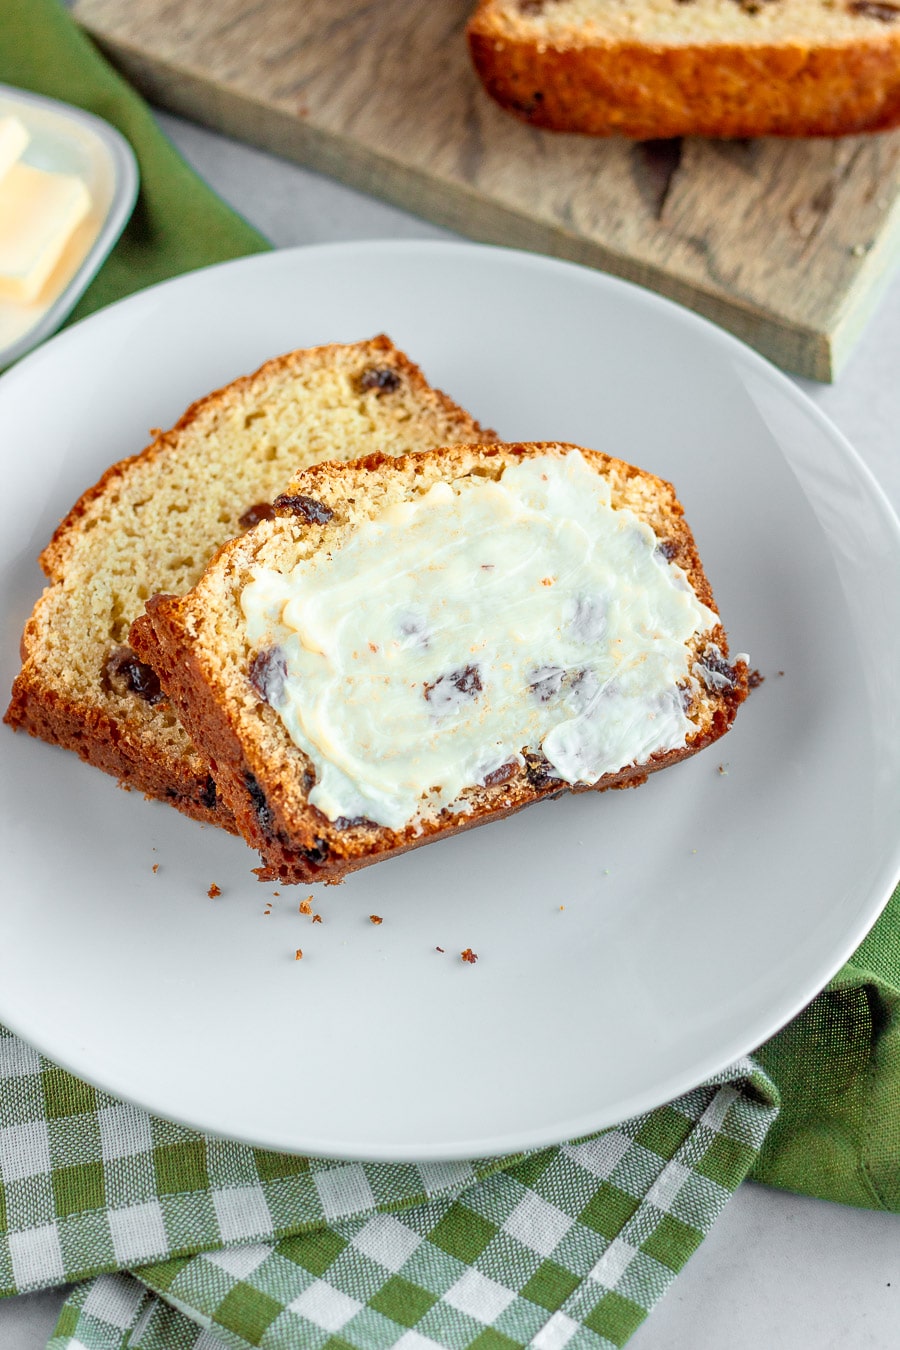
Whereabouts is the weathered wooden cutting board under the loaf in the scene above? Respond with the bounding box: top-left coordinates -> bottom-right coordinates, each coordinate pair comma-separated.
76,0 -> 900,381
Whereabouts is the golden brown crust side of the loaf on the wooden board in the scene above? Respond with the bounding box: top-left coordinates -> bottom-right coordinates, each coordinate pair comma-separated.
468,3 -> 900,139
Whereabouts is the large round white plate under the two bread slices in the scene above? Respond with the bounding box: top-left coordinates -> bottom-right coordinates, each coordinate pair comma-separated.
0,243 -> 900,1160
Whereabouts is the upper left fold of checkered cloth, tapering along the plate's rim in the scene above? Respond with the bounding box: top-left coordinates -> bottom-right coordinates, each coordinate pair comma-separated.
0,1029 -> 523,1297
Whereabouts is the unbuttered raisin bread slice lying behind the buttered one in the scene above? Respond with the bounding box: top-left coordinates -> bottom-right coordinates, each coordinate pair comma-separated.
5,336 -> 493,829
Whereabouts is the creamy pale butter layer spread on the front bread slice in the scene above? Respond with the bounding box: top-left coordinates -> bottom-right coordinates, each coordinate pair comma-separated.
242,451 -> 718,829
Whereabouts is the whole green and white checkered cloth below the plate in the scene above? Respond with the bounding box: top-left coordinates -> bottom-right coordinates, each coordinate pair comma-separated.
0,1029 -> 777,1350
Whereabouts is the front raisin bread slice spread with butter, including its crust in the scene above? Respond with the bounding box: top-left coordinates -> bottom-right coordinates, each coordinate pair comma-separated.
140,444 -> 748,883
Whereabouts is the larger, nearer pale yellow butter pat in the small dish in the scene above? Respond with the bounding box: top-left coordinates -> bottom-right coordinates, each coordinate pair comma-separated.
0,163 -> 90,304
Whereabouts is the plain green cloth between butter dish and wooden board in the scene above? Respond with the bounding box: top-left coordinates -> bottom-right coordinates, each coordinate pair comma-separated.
0,0 -> 269,323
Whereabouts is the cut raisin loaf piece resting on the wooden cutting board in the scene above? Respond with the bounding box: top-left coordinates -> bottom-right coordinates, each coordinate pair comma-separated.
468,0 -> 900,139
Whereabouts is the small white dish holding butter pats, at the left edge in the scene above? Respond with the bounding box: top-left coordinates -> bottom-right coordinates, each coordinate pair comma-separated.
0,85 -> 138,370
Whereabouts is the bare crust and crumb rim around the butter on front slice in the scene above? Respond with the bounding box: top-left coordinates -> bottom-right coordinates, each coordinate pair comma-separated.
132,444 -> 748,884
